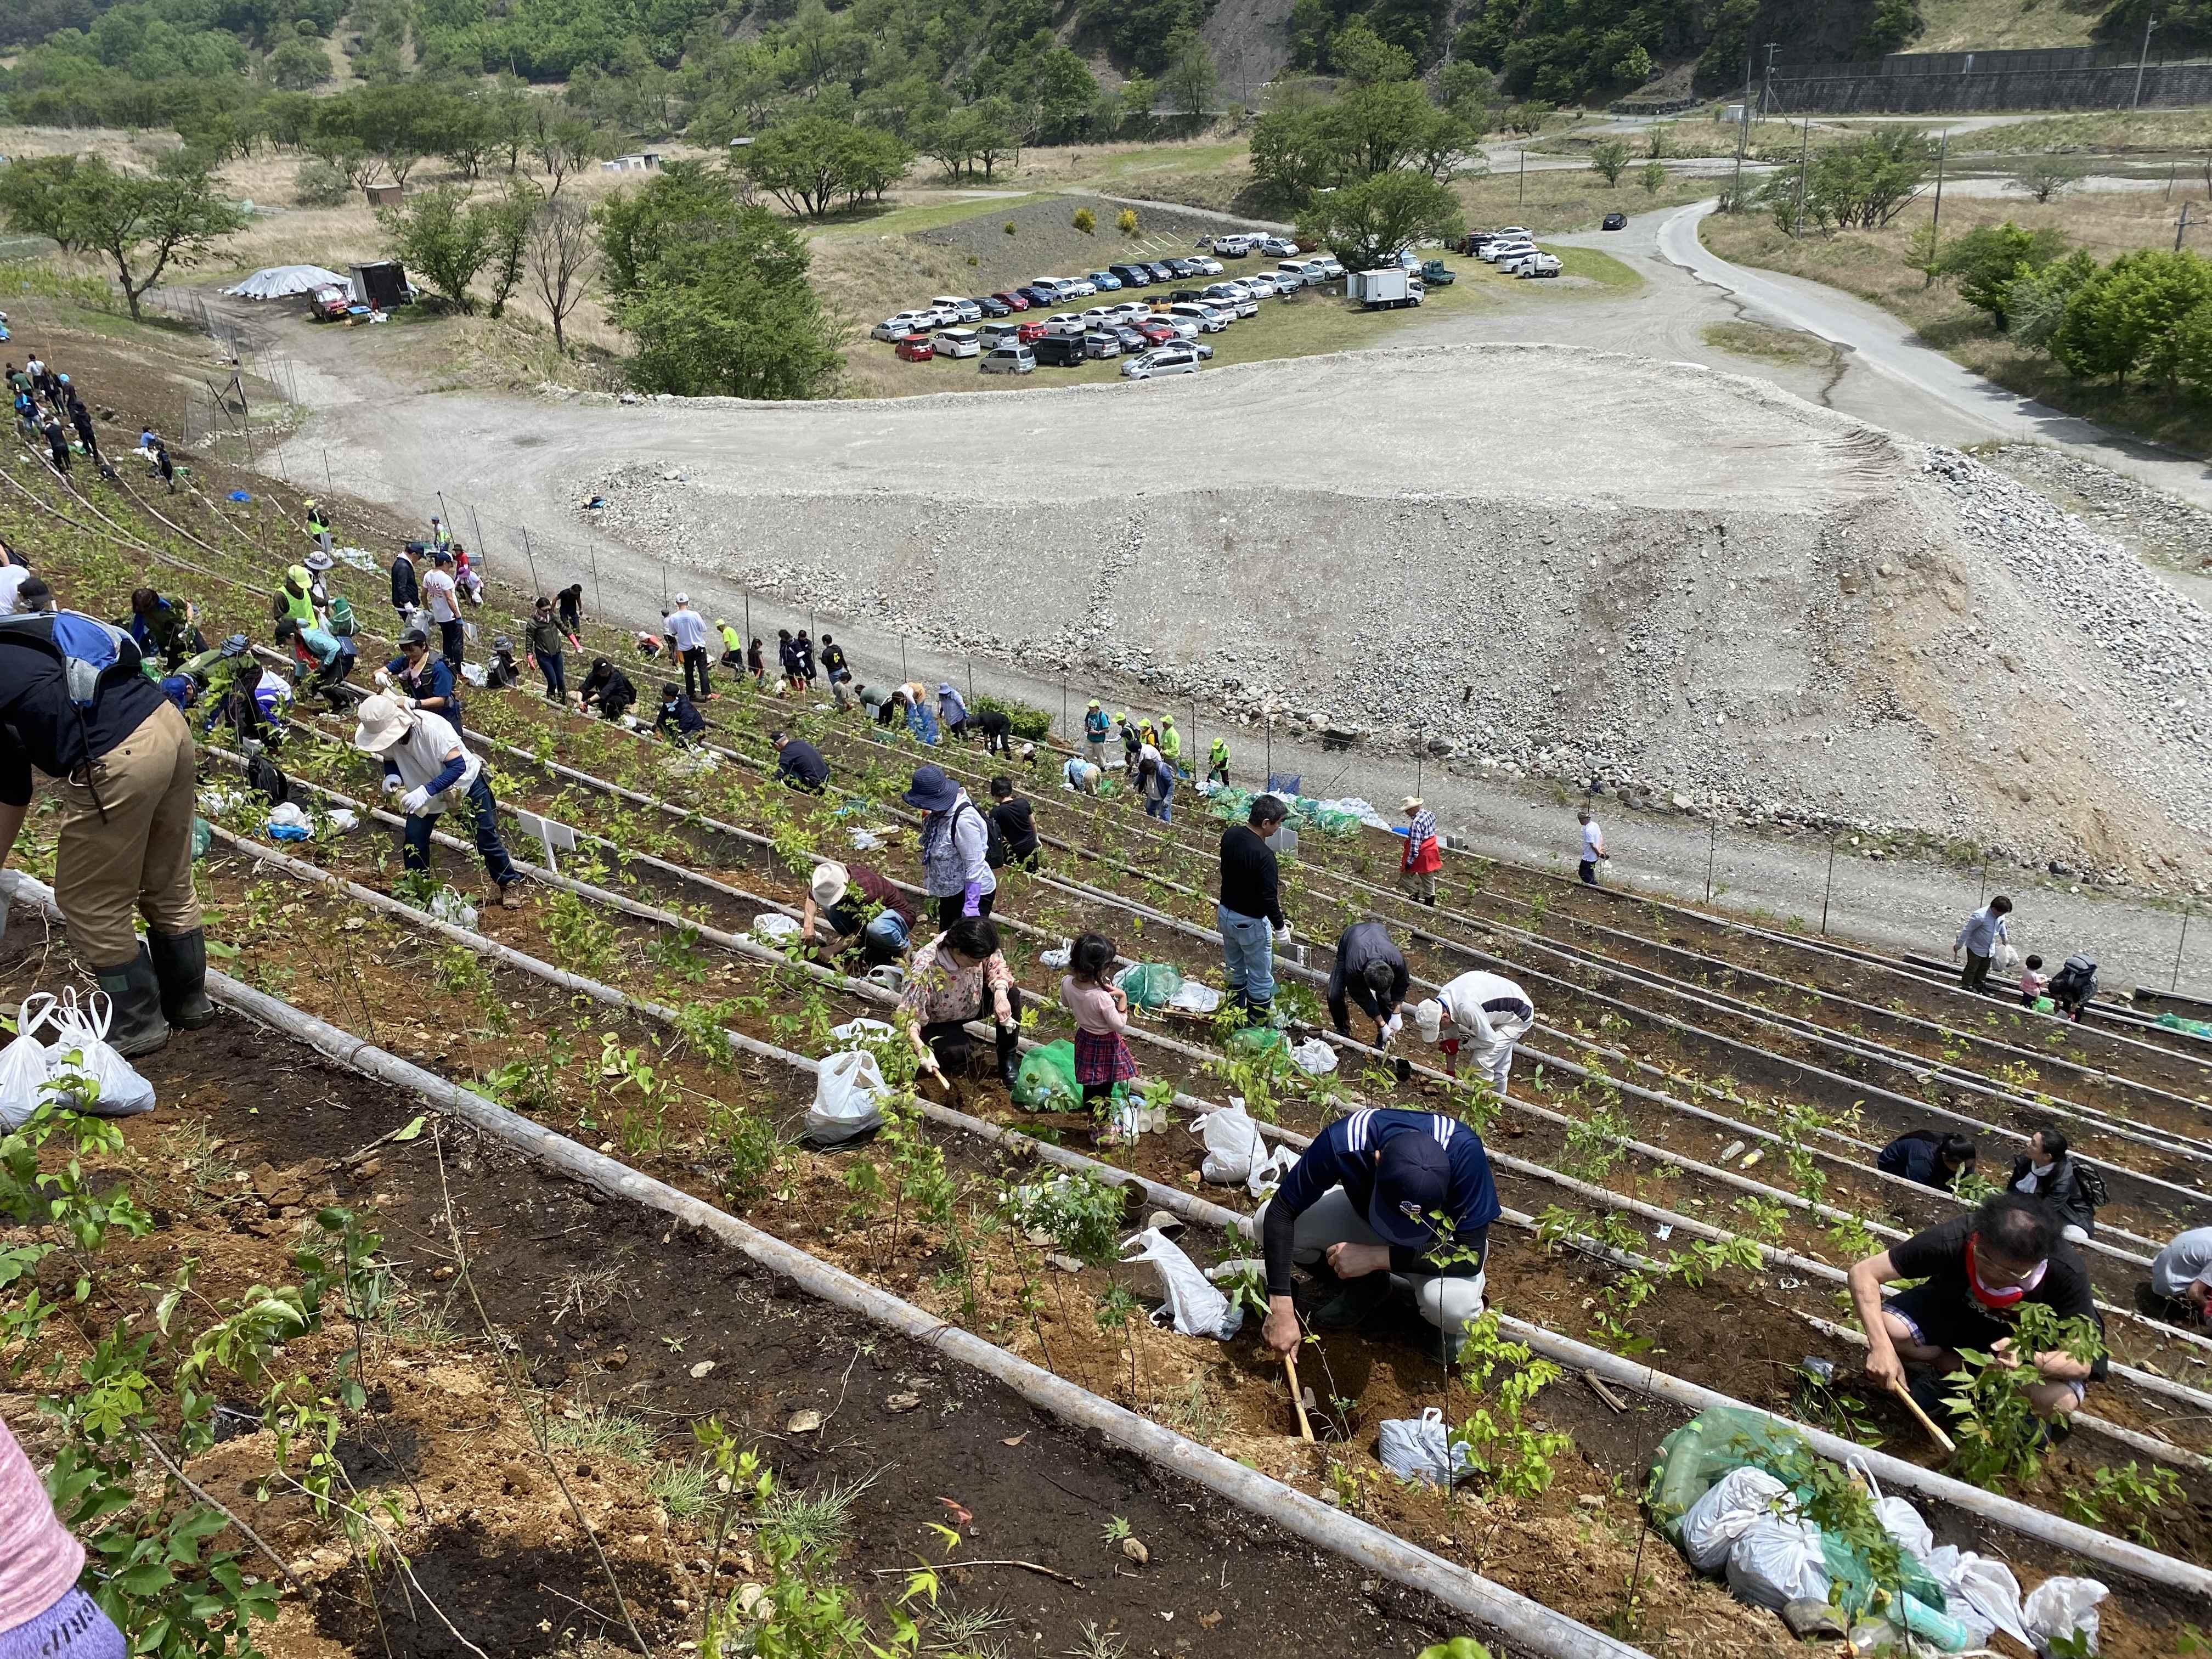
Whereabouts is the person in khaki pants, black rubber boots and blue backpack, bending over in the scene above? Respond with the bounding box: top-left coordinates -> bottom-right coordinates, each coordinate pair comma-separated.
0,611 -> 215,1057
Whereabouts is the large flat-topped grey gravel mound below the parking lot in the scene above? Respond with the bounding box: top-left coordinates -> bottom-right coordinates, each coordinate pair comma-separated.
591,345 -> 2212,881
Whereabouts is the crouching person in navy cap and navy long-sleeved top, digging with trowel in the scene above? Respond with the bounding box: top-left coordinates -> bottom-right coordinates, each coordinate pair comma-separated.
1256,1110 -> 1500,1365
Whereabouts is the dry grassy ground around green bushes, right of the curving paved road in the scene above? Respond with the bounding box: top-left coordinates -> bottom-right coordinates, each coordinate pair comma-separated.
1699,179 -> 2212,456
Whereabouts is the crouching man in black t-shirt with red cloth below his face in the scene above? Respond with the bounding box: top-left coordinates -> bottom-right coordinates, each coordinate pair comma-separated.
1849,1192 -> 2108,1418
